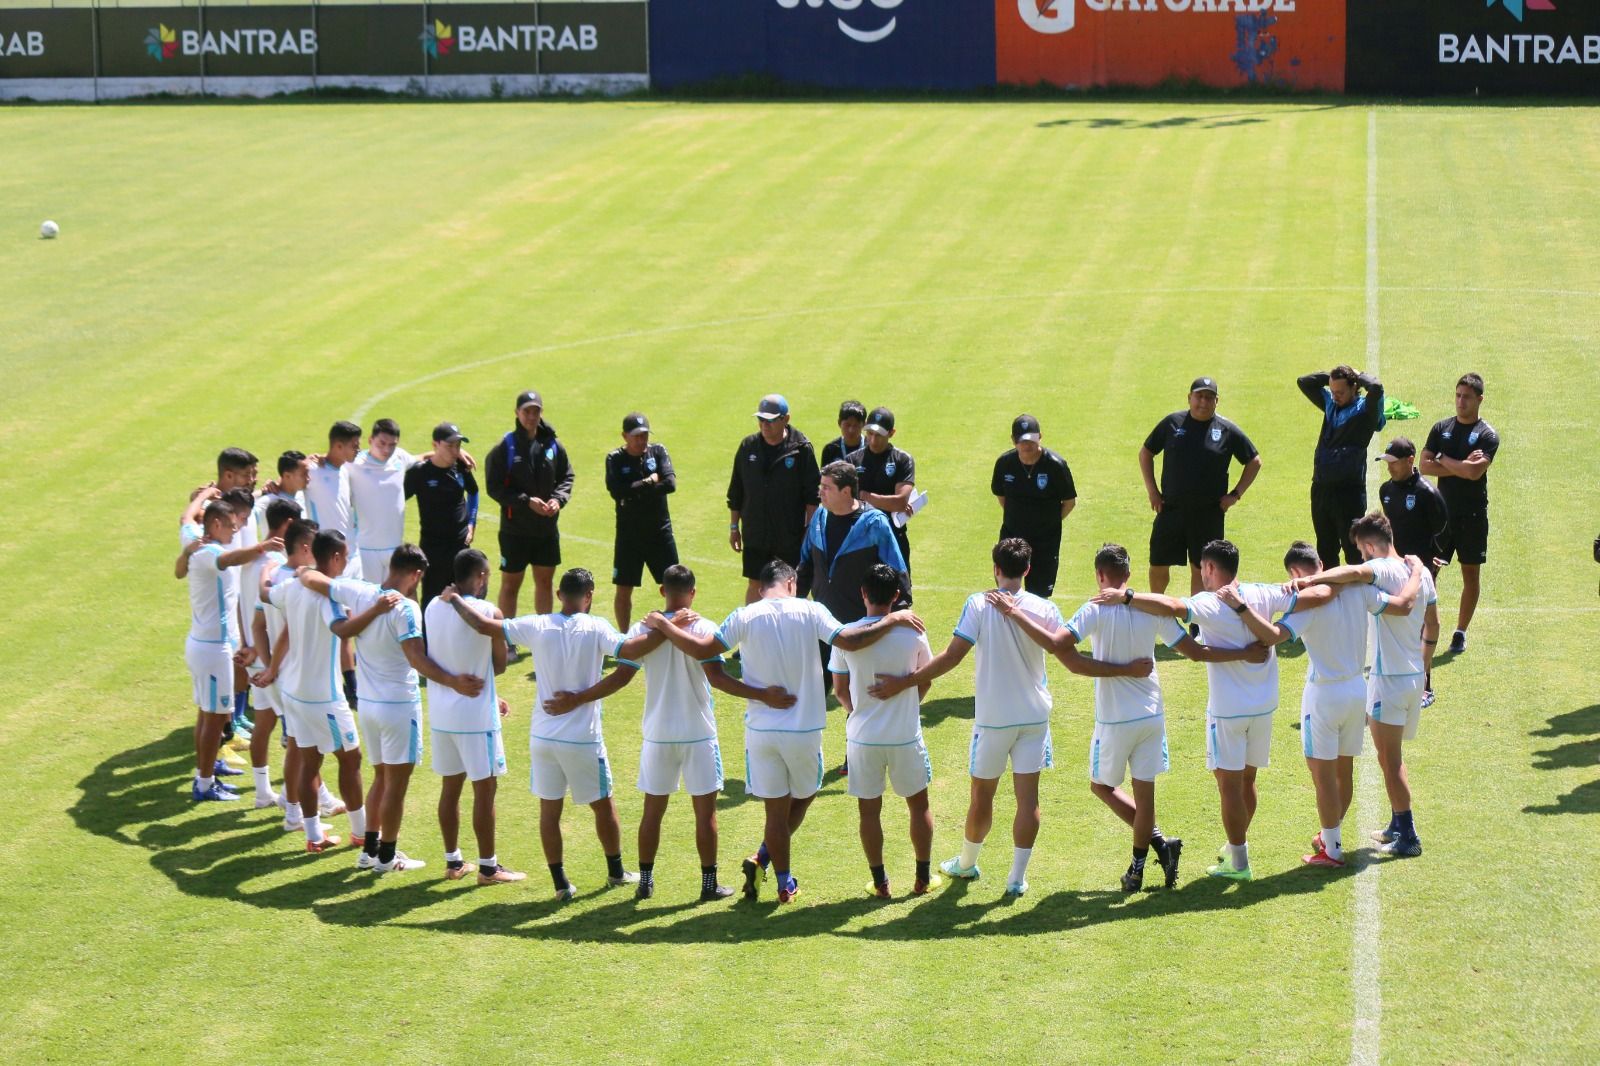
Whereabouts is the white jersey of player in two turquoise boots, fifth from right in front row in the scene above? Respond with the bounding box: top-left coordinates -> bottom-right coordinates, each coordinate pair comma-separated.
955,592 -> 1061,728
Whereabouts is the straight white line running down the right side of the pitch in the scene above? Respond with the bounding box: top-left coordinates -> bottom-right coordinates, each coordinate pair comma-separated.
1350,109 -> 1384,1066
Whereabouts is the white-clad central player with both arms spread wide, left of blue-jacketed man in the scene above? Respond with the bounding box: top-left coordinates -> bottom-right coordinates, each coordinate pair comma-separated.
645,559 -> 922,903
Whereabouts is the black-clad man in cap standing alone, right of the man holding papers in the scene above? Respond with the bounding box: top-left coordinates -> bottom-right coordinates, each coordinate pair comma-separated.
989,415 -> 1078,599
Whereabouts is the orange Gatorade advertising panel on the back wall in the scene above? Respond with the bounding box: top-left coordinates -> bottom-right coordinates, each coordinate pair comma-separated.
995,0 -> 1344,93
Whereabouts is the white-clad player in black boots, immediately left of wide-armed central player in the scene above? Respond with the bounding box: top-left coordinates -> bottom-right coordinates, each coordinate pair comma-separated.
627,563 -> 795,901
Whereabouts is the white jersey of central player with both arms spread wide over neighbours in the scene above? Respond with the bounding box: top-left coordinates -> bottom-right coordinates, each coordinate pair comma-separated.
717,595 -> 840,733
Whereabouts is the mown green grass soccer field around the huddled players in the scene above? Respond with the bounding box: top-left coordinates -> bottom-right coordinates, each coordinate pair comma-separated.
0,101 -> 1600,1063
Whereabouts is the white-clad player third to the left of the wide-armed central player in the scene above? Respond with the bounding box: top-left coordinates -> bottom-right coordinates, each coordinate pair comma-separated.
422,547 -> 528,885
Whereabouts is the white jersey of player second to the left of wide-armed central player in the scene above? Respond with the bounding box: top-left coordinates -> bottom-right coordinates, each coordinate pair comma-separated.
506,611 -> 638,744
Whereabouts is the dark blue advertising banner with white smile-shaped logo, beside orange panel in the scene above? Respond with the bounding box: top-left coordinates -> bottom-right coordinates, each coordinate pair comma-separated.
650,0 -> 995,90
